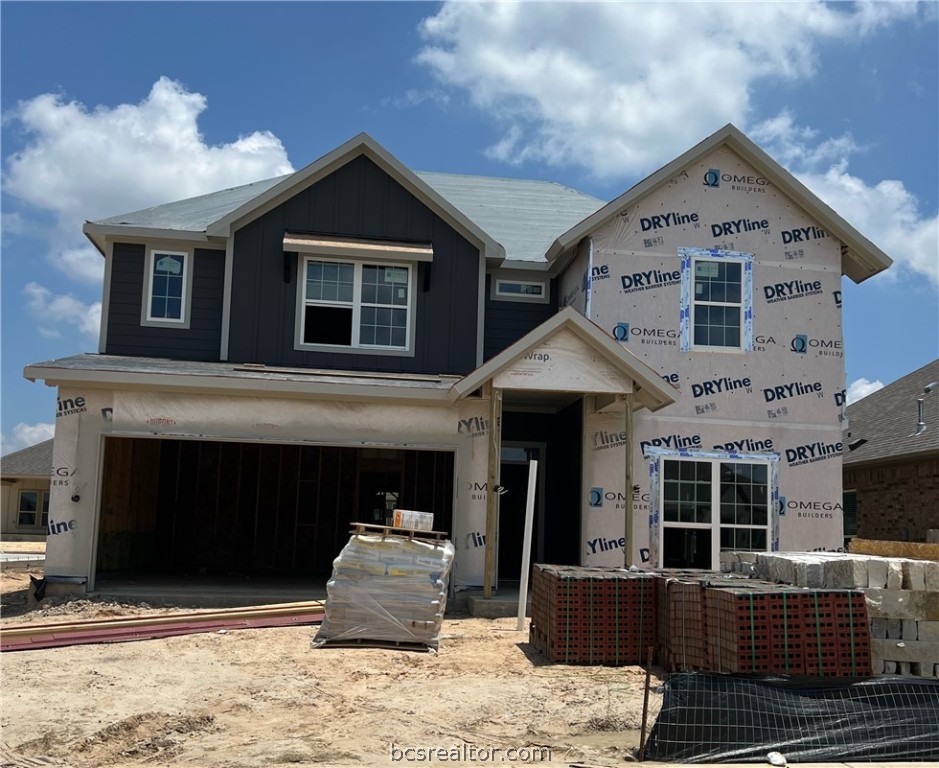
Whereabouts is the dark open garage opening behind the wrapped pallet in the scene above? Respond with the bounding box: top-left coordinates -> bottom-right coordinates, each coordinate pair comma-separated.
96,437 -> 454,588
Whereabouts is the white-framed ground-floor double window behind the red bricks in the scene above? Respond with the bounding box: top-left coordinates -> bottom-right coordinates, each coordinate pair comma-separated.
659,456 -> 773,570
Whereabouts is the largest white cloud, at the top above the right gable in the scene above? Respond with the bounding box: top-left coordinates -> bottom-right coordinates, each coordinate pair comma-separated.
417,2 -> 917,178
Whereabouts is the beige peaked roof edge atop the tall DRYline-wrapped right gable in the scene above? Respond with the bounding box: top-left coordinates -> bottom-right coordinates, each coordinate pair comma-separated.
547,123 -> 893,283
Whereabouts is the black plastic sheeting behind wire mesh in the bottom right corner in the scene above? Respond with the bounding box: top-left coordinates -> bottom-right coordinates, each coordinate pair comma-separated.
645,673 -> 939,763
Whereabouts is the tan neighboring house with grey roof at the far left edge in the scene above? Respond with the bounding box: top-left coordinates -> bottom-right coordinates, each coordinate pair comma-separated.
0,440 -> 52,541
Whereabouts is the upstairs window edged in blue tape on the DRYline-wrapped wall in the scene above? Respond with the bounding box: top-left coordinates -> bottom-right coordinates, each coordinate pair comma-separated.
679,248 -> 753,351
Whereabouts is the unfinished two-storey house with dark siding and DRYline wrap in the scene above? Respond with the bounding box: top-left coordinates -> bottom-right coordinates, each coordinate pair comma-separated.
25,126 -> 890,589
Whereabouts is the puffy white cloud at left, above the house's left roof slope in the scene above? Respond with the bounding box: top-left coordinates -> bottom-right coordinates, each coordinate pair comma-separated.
3,77 -> 293,335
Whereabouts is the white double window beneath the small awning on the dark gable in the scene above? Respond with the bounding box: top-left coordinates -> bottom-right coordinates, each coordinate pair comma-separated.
297,257 -> 414,351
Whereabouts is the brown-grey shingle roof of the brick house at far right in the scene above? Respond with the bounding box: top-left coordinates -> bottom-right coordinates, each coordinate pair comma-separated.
843,360 -> 939,466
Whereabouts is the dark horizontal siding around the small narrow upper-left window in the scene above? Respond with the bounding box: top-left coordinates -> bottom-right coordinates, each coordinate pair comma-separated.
105,243 -> 225,361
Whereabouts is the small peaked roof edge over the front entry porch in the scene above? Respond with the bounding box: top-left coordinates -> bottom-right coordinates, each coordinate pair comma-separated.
450,307 -> 675,411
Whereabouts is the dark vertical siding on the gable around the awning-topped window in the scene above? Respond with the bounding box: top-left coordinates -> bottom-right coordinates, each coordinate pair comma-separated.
228,157 -> 479,374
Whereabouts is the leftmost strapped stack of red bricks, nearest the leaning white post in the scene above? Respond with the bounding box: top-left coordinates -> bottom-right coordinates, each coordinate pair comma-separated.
530,565 -> 655,666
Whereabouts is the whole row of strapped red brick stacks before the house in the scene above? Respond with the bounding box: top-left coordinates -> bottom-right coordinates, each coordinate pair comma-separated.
531,565 -> 871,677
